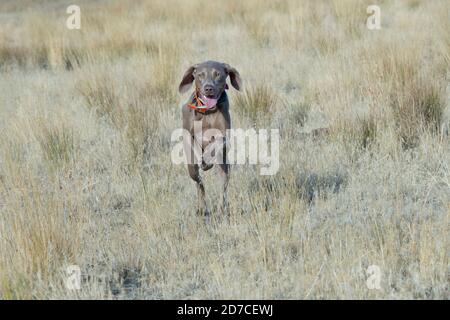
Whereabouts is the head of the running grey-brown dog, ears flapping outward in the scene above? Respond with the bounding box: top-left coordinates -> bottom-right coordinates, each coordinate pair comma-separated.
178,61 -> 242,107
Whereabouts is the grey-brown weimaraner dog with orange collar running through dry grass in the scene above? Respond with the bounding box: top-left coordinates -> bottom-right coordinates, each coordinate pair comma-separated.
178,61 -> 242,216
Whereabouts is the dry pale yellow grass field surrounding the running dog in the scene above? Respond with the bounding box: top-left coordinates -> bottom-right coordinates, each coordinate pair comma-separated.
0,0 -> 450,299
